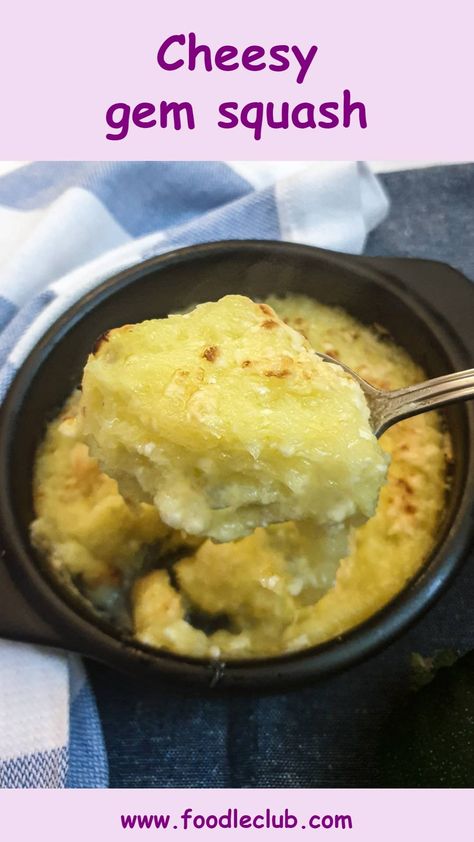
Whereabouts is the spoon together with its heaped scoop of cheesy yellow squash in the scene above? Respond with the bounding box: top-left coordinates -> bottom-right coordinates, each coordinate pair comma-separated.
79,295 -> 474,542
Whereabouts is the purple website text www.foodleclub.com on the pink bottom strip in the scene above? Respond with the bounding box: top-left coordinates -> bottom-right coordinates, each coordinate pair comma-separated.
120,807 -> 352,831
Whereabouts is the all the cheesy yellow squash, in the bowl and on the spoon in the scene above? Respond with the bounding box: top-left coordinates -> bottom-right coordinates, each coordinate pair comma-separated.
31,295 -> 450,658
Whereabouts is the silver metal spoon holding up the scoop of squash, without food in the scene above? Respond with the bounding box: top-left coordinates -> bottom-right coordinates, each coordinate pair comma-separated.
318,354 -> 474,438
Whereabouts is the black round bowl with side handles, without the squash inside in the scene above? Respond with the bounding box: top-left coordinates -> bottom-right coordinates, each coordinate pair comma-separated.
0,241 -> 474,688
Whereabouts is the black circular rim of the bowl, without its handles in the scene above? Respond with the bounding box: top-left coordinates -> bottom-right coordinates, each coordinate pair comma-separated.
0,240 -> 474,689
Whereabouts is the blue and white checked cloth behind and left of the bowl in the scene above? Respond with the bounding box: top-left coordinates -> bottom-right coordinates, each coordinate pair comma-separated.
0,161 -> 388,787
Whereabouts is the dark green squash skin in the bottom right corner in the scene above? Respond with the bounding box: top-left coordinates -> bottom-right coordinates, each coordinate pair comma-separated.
380,651 -> 474,787
